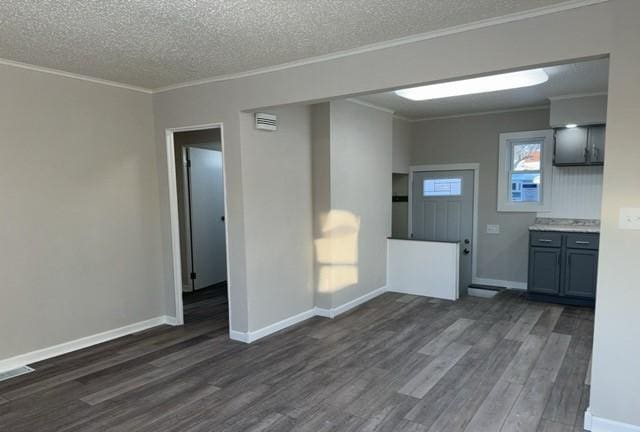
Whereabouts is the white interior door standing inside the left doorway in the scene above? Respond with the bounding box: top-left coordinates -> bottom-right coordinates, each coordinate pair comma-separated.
187,147 -> 227,289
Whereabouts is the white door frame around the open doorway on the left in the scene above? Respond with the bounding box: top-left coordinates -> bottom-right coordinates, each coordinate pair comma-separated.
165,123 -> 232,329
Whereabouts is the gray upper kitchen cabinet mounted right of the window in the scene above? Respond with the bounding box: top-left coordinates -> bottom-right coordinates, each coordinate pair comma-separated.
553,125 -> 605,166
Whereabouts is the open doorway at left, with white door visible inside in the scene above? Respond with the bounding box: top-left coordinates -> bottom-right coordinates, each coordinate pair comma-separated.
167,125 -> 229,325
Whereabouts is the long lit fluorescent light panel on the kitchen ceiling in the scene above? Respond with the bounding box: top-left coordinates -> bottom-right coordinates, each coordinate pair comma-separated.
395,69 -> 549,101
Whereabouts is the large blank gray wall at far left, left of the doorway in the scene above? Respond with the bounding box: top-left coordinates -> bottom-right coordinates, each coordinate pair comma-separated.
0,65 -> 161,359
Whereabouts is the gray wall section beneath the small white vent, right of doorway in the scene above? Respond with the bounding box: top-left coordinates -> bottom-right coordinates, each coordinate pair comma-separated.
238,105 -> 314,331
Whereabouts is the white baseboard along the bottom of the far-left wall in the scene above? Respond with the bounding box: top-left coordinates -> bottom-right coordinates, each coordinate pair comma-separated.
0,315 -> 176,372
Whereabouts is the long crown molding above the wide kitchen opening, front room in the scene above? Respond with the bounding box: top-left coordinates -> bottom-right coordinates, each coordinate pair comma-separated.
153,0 -> 609,93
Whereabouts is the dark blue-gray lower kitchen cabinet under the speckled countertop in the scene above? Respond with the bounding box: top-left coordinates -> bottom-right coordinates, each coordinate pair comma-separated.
527,231 -> 599,305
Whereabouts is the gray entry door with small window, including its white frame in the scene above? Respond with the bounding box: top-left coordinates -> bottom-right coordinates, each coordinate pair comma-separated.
409,164 -> 478,296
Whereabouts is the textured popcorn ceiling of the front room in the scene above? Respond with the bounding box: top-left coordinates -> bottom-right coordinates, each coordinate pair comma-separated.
0,0 -> 576,88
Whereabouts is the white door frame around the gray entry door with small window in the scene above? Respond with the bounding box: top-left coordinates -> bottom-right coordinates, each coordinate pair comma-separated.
408,162 -> 480,283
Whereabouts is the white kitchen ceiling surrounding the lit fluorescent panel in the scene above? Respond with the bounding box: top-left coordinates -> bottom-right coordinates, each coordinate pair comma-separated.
358,59 -> 609,119
